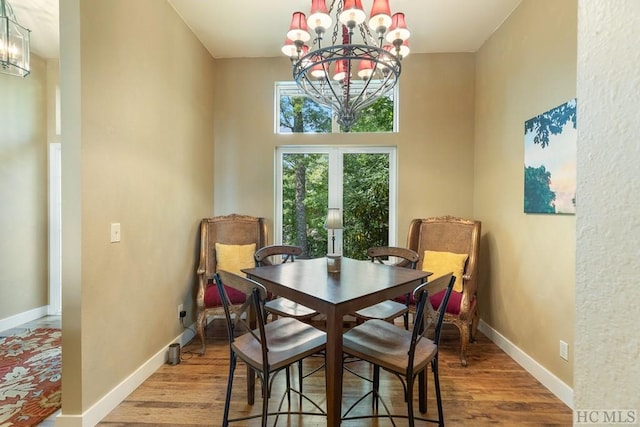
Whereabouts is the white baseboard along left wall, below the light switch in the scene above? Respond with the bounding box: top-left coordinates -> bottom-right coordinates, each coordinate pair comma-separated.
56,324 -> 195,427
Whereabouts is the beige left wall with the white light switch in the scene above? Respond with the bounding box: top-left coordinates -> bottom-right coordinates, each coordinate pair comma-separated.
61,0 -> 214,418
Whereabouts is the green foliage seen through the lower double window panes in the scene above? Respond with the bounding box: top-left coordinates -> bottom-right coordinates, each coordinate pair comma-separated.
282,153 -> 389,259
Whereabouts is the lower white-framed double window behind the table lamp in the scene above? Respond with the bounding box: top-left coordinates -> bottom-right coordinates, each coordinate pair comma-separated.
275,147 -> 396,259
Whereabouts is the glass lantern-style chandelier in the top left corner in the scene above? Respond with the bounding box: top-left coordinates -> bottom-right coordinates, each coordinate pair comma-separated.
0,0 -> 31,77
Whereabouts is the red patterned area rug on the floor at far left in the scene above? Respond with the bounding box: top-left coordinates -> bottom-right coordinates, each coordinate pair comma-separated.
0,328 -> 61,427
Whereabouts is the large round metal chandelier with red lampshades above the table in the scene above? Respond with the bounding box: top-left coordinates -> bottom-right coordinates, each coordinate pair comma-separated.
282,0 -> 410,132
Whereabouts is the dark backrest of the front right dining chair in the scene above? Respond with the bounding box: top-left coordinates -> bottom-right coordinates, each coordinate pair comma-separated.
408,273 -> 456,367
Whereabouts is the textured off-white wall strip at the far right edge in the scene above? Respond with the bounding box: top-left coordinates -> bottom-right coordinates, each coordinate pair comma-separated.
574,0 -> 640,414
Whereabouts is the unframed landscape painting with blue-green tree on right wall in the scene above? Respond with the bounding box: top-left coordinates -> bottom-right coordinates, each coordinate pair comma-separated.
524,98 -> 577,214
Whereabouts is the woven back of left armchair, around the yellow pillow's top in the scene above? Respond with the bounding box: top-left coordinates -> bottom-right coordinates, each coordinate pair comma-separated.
200,214 -> 267,278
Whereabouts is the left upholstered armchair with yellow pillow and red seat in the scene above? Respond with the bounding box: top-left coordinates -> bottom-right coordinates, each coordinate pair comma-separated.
196,214 -> 267,355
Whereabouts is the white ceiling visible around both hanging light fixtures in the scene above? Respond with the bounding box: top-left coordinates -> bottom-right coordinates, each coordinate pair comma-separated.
10,0 -> 521,58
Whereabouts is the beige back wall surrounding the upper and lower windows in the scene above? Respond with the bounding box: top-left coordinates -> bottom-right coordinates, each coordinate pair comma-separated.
214,54 -> 475,244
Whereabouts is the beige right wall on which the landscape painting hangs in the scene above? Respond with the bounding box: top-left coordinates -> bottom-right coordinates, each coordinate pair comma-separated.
474,0 -> 580,386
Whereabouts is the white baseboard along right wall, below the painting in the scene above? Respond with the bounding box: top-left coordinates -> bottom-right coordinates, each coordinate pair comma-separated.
478,320 -> 573,409
